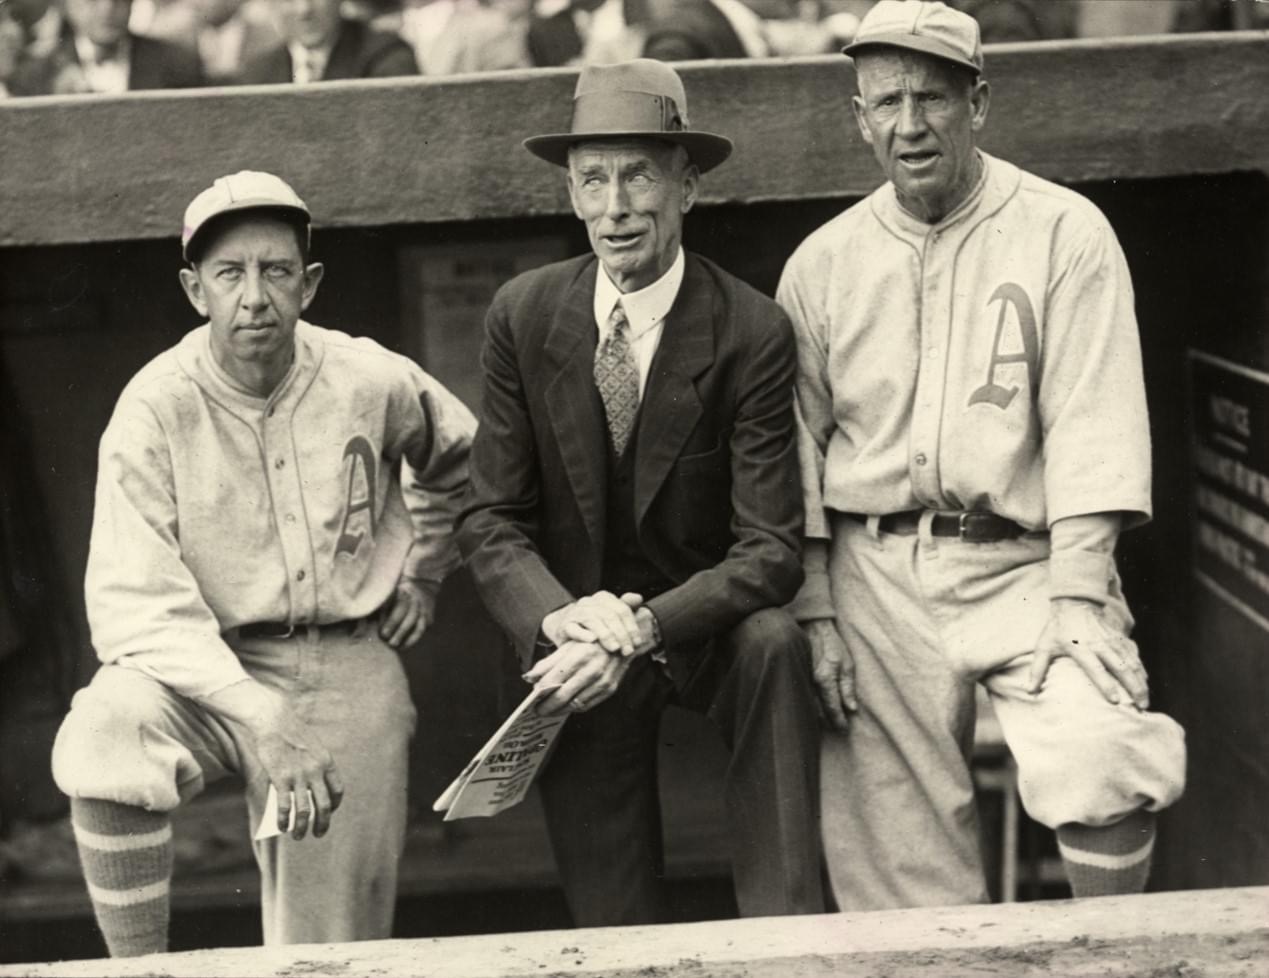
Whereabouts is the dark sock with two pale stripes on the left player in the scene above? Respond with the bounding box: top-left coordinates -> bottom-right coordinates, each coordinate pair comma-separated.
71,798 -> 173,958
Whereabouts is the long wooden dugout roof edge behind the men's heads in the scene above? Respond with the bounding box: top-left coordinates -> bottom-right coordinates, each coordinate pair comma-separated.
0,32 -> 1269,247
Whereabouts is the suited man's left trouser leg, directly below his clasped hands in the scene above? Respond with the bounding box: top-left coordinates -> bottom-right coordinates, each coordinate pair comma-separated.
539,656 -> 671,927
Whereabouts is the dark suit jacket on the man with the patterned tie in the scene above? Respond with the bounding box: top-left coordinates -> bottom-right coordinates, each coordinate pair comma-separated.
458,255 -> 802,662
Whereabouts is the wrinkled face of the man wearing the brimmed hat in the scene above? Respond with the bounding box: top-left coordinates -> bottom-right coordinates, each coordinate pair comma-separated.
569,140 -> 699,292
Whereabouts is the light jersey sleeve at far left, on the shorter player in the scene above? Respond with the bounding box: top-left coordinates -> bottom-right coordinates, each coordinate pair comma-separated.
85,402 -> 247,699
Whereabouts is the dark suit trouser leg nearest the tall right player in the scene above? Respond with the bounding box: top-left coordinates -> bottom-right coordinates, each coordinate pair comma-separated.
683,608 -> 824,917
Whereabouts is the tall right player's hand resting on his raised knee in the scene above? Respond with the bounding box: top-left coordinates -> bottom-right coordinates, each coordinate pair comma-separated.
1030,597 -> 1150,709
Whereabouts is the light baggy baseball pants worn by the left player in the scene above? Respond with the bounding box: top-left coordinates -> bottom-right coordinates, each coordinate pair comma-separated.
53,622 -> 415,944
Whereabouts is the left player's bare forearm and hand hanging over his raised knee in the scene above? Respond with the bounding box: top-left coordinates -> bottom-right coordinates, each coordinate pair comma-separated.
206,679 -> 344,840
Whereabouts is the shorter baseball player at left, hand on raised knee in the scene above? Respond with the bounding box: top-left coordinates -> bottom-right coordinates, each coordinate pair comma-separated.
53,171 -> 475,956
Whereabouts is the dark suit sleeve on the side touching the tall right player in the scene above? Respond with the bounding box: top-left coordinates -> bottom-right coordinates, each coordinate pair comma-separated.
648,303 -> 802,649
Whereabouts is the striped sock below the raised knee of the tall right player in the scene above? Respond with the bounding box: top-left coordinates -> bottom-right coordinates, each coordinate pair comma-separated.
1057,811 -> 1155,897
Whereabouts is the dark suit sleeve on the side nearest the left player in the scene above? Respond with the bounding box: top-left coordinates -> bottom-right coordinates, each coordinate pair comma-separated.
458,292 -> 574,662
